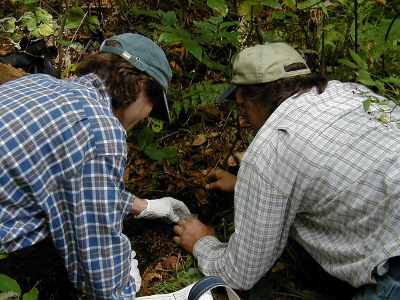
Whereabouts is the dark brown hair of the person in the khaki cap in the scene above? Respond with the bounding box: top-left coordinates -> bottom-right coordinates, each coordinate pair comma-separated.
240,63 -> 328,114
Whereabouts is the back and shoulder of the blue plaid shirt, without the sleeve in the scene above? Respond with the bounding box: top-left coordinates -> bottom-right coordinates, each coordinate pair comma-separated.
0,74 -> 126,252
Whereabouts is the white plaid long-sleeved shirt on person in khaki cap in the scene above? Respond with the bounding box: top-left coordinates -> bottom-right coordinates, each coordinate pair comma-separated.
194,81 -> 400,289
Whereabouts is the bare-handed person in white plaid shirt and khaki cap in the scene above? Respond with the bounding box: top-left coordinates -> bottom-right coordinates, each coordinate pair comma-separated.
174,43 -> 400,299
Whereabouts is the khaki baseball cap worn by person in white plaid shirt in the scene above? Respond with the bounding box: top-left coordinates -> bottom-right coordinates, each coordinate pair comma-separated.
216,42 -> 311,102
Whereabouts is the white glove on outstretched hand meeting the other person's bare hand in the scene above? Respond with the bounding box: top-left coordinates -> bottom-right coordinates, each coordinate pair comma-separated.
136,197 -> 190,223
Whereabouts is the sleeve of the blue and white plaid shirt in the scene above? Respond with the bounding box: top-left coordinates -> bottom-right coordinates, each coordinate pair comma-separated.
49,156 -> 136,299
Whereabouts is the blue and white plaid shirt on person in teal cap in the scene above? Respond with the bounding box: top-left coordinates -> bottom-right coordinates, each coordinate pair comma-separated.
0,74 -> 135,300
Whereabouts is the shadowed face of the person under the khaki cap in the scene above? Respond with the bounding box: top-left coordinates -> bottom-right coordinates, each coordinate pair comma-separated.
236,87 -> 269,132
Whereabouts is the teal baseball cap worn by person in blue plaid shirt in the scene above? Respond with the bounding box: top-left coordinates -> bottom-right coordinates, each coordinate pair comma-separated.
99,33 -> 172,123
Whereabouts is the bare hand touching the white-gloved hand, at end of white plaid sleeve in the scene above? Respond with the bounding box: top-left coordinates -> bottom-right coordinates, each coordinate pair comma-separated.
173,218 -> 215,253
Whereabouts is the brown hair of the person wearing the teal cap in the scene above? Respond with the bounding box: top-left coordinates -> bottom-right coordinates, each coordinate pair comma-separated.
76,41 -> 163,109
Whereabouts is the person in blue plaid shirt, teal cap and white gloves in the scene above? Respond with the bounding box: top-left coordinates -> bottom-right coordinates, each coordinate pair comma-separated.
0,33 -> 190,300
